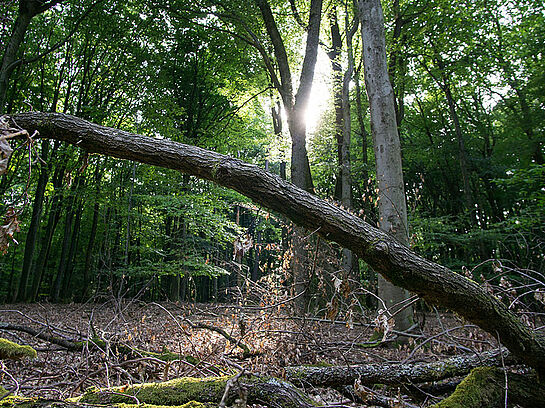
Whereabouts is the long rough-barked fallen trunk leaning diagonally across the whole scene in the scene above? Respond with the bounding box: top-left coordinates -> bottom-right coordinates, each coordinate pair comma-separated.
6,112 -> 545,376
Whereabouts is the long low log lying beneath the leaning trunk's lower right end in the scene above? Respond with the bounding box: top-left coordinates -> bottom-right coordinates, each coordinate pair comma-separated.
286,349 -> 514,387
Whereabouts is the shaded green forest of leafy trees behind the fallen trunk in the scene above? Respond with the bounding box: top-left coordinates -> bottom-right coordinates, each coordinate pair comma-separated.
0,0 -> 545,314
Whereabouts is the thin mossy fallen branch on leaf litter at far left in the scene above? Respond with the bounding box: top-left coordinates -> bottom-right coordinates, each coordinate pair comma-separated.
0,322 -> 199,364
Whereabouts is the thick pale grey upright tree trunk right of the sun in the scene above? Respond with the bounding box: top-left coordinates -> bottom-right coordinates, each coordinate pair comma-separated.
358,0 -> 412,331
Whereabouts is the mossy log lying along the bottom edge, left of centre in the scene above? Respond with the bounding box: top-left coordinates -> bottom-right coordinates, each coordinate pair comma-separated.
77,376 -> 318,408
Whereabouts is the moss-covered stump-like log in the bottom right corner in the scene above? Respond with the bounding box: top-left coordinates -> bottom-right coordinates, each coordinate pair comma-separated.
432,367 -> 545,408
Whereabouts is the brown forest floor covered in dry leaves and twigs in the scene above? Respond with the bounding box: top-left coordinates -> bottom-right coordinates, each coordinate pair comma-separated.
0,301 -> 497,406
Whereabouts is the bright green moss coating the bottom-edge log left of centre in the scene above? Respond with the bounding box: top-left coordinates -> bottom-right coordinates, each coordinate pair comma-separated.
79,377 -> 229,406
